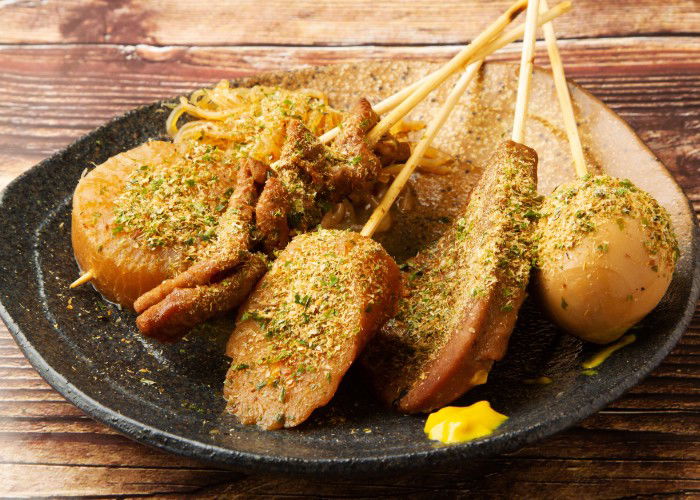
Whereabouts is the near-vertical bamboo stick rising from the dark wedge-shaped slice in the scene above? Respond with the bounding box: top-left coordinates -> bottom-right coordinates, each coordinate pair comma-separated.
511,0 -> 539,144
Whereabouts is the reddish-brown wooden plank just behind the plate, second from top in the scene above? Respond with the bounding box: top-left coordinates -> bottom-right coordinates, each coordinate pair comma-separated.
0,37 -> 700,197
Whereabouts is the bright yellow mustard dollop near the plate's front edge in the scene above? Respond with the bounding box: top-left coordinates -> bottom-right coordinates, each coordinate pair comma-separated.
423,401 -> 508,444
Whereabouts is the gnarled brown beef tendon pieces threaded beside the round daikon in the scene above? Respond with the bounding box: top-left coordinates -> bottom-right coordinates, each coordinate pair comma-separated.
134,99 -> 391,341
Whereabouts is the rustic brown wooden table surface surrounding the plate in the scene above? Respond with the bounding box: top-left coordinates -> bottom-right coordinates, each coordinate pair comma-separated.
0,0 -> 700,498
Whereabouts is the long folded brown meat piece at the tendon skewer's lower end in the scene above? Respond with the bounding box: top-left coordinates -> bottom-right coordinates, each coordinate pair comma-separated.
134,160 -> 264,340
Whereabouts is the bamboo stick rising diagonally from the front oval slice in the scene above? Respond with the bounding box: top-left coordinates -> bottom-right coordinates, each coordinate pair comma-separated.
360,61 -> 481,238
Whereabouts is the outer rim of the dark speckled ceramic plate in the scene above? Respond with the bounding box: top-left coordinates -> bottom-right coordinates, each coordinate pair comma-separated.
0,64 -> 700,476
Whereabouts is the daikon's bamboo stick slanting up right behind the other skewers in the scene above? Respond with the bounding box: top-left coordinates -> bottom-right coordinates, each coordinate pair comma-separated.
319,0 -> 572,144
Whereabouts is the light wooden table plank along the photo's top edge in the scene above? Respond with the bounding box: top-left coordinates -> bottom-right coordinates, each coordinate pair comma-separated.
0,0 -> 700,45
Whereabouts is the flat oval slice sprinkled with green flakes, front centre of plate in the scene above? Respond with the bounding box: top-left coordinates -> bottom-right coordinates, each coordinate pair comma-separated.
224,229 -> 400,429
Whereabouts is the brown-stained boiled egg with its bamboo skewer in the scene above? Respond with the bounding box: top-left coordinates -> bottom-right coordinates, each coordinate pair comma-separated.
535,0 -> 678,344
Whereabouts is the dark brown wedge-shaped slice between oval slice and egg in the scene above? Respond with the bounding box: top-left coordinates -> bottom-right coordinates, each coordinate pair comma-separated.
362,141 -> 540,413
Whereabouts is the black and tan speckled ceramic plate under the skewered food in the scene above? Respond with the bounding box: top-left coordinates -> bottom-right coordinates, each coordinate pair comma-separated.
0,62 -> 698,474
